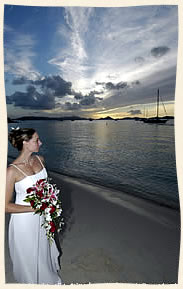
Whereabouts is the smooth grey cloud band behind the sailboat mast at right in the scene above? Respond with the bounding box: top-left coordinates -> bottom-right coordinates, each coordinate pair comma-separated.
102,66 -> 176,108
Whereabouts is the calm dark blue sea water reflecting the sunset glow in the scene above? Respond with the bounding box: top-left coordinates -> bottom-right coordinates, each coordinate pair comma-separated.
8,120 -> 179,209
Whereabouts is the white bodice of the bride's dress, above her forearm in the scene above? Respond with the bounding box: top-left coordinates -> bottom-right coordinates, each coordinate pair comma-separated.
15,167 -> 48,206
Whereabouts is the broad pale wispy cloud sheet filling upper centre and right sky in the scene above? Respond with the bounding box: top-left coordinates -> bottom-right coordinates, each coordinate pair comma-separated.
49,6 -> 177,98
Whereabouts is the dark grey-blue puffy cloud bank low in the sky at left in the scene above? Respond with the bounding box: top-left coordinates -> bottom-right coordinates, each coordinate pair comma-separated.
6,75 -> 103,110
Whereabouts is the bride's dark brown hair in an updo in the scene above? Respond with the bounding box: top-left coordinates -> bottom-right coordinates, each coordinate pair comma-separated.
8,128 -> 36,151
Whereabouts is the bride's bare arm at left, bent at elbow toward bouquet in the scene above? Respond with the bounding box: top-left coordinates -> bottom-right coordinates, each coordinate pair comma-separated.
5,167 -> 35,213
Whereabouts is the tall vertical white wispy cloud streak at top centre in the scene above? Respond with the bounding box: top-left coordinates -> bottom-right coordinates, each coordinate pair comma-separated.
49,7 -> 93,82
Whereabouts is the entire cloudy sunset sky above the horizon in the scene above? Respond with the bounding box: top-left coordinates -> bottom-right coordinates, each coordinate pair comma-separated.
4,5 -> 178,118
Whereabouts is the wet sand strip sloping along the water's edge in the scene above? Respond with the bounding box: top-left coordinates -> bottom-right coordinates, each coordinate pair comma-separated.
49,171 -> 180,228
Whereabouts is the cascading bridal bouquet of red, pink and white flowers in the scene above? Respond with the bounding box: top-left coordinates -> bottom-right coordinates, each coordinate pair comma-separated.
24,178 -> 63,243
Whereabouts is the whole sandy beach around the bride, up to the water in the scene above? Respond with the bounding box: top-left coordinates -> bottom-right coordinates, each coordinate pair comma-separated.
5,172 -> 180,284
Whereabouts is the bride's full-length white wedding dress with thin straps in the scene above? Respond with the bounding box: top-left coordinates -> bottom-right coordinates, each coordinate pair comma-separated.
8,157 -> 62,284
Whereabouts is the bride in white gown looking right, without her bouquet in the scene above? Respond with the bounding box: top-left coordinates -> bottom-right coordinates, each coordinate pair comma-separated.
5,128 -> 62,284
